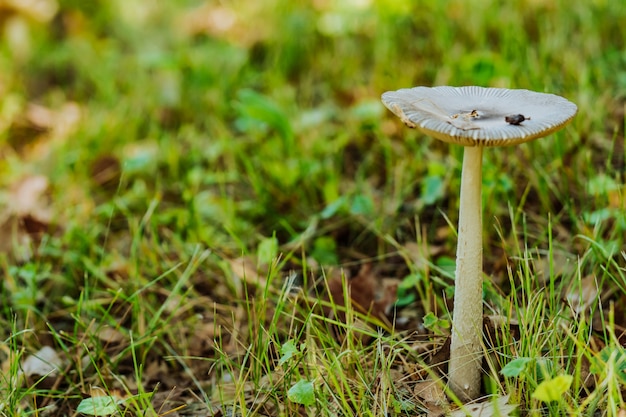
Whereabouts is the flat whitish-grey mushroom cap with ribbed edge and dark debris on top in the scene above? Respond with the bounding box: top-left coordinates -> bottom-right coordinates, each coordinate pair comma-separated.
382,86 -> 578,146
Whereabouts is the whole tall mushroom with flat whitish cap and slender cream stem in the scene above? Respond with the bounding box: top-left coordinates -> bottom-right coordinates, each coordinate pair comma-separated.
382,86 -> 577,401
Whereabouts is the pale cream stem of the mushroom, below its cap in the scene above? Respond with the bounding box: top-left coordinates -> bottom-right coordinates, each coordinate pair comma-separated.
448,146 -> 483,401
